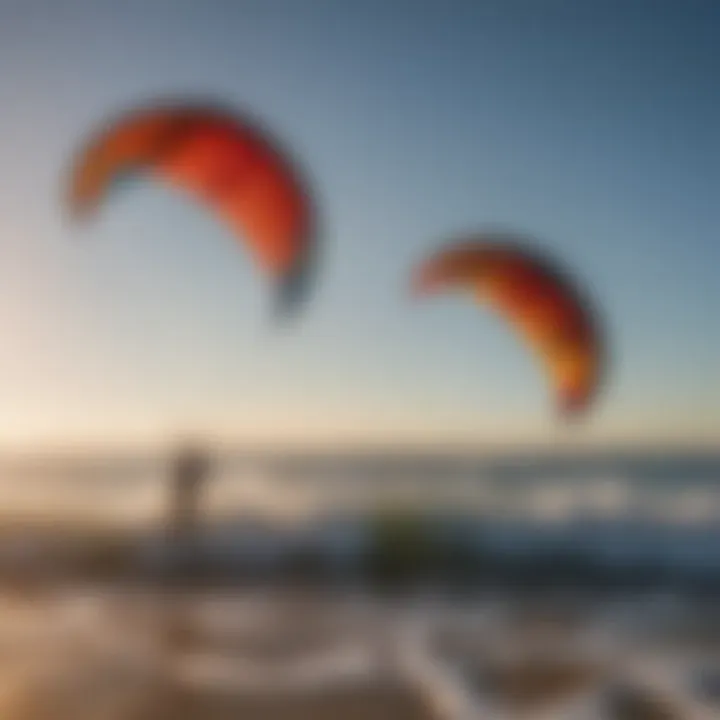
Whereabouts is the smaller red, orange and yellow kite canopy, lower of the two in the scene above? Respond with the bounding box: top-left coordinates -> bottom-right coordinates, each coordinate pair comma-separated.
412,234 -> 603,417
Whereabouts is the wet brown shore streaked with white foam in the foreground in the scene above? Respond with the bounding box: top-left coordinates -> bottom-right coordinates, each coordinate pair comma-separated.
0,589 -> 720,720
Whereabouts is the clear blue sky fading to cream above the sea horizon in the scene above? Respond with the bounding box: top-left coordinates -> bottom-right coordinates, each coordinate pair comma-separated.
0,0 -> 720,445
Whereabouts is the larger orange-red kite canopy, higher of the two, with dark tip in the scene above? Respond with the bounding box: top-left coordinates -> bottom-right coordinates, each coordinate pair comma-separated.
67,103 -> 315,316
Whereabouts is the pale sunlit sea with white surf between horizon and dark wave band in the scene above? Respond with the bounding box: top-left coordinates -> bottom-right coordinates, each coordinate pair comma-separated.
0,451 -> 720,573
